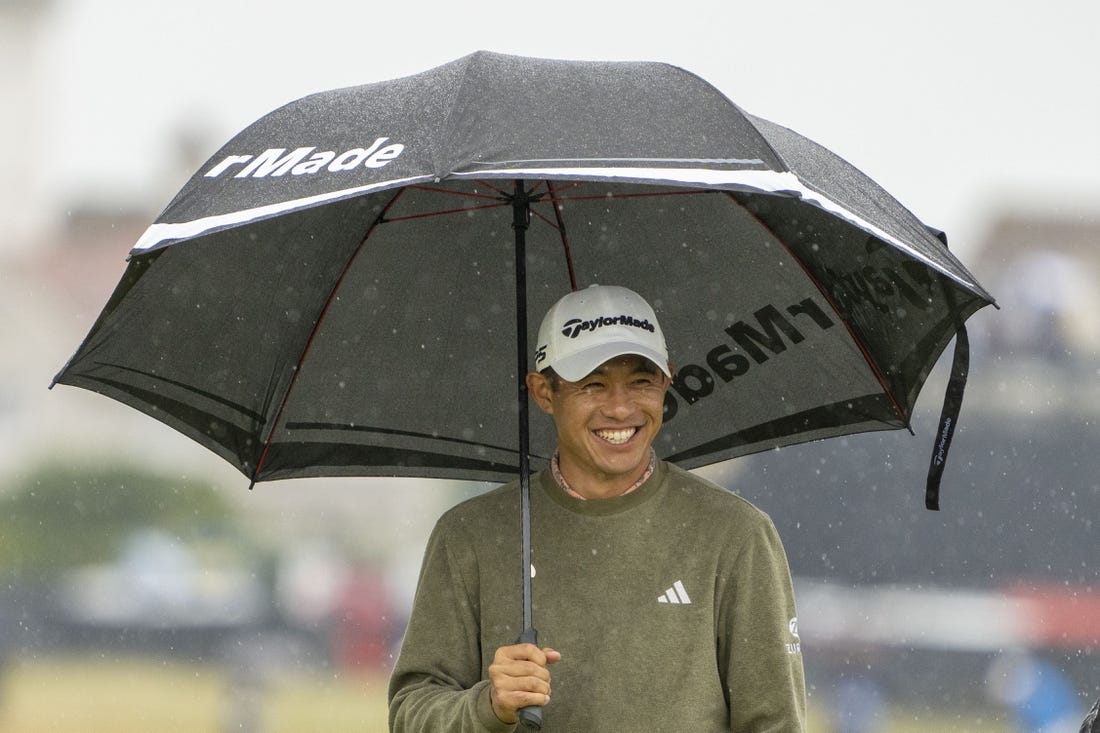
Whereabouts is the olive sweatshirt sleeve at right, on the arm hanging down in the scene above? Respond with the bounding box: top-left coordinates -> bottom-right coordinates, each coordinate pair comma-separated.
718,513 -> 806,733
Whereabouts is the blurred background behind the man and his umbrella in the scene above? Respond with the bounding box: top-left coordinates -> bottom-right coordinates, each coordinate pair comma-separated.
0,0 -> 1100,733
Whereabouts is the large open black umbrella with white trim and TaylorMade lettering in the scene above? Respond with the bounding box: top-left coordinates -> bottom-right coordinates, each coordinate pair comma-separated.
55,52 -> 992,726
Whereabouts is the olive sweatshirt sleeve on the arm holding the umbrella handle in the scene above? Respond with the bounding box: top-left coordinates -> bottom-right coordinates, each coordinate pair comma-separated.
389,512 -> 516,733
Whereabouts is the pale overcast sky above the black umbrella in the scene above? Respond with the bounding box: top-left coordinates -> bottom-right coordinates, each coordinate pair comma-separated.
34,0 -> 1100,253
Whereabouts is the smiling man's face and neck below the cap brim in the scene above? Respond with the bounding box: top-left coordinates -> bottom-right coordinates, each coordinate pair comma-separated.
527,355 -> 669,499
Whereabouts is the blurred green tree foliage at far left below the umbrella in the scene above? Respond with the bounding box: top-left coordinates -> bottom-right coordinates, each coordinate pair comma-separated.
0,463 -> 233,575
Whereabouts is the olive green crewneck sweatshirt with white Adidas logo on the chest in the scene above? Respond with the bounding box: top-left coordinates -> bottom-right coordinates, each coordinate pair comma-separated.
389,461 -> 805,733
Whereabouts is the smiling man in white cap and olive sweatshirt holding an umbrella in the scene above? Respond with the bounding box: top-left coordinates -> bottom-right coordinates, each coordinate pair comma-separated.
389,286 -> 805,733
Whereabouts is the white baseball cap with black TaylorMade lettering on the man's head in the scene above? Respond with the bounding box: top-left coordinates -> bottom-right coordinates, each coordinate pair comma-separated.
535,285 -> 672,382
